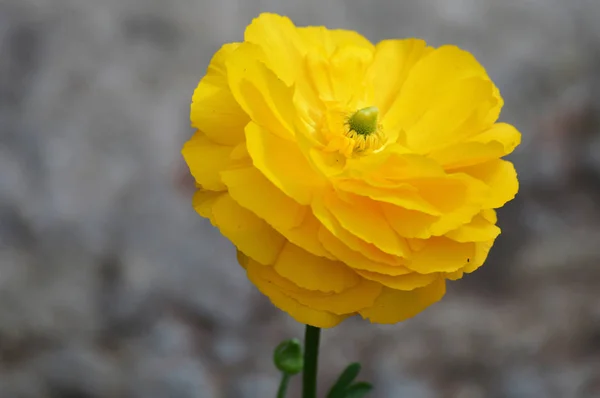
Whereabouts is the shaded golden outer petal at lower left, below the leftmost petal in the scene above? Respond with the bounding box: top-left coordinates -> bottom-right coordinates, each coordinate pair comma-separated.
199,193 -> 285,264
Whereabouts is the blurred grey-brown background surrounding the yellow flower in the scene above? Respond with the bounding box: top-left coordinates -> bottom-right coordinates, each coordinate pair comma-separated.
0,0 -> 600,398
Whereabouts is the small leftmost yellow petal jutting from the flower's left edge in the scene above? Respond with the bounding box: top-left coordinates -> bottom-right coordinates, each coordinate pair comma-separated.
181,131 -> 234,191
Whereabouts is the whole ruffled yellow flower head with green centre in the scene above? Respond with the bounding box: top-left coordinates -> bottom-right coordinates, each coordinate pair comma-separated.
183,14 -> 520,327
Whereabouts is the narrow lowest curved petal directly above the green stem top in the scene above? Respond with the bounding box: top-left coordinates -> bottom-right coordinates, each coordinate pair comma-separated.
247,261 -> 348,328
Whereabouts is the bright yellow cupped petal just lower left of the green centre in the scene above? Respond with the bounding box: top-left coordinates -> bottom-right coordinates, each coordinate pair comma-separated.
246,122 -> 325,205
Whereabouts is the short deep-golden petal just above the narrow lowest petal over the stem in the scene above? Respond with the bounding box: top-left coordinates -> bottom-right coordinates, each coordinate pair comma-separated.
273,242 -> 360,293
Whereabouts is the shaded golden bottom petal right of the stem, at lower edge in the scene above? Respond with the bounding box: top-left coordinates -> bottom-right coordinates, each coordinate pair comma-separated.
360,279 -> 446,324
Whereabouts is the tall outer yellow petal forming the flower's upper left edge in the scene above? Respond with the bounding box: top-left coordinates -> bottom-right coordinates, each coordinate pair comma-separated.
190,43 -> 250,145
